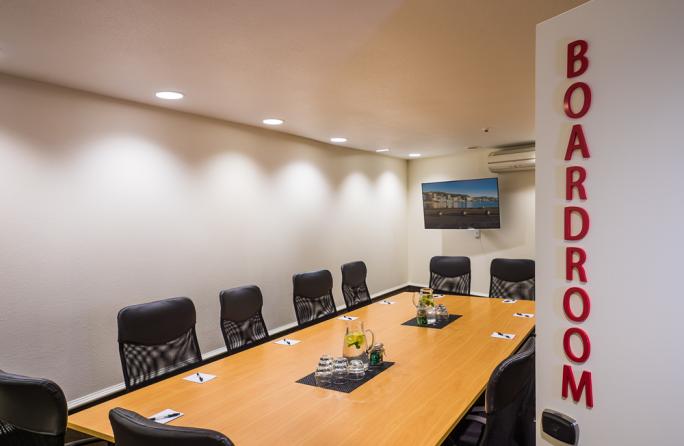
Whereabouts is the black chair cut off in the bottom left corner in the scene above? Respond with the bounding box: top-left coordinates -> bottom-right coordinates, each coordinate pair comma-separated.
0,370 -> 102,446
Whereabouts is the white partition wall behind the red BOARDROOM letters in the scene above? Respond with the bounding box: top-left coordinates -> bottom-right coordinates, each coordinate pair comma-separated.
536,0 -> 684,446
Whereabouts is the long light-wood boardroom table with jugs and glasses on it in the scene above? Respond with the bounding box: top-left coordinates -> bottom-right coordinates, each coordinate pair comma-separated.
68,292 -> 535,446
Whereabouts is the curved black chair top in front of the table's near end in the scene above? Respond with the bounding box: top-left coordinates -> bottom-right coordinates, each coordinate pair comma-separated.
109,407 -> 233,446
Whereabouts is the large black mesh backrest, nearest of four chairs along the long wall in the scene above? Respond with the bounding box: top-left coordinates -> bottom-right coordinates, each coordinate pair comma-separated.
117,297 -> 202,389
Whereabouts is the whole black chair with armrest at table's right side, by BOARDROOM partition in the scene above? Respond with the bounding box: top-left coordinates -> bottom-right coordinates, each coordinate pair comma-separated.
445,337 -> 535,446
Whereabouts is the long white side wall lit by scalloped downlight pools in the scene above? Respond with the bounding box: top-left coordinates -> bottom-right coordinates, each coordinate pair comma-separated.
0,75 -> 407,399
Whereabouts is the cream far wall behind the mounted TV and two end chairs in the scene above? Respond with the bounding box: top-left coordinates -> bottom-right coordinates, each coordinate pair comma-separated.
408,149 -> 534,295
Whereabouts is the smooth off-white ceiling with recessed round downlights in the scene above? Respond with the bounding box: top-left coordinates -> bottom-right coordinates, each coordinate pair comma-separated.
0,0 -> 585,157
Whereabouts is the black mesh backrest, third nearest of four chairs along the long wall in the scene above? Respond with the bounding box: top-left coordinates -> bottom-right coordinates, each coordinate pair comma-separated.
292,269 -> 337,325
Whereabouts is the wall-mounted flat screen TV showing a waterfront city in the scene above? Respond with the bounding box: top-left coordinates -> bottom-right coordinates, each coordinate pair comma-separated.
423,178 -> 501,229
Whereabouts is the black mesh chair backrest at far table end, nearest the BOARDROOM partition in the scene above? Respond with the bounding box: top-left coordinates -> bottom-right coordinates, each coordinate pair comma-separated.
489,259 -> 534,300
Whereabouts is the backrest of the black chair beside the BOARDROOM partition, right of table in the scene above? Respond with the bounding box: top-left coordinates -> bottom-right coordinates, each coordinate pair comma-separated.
480,336 -> 535,446
